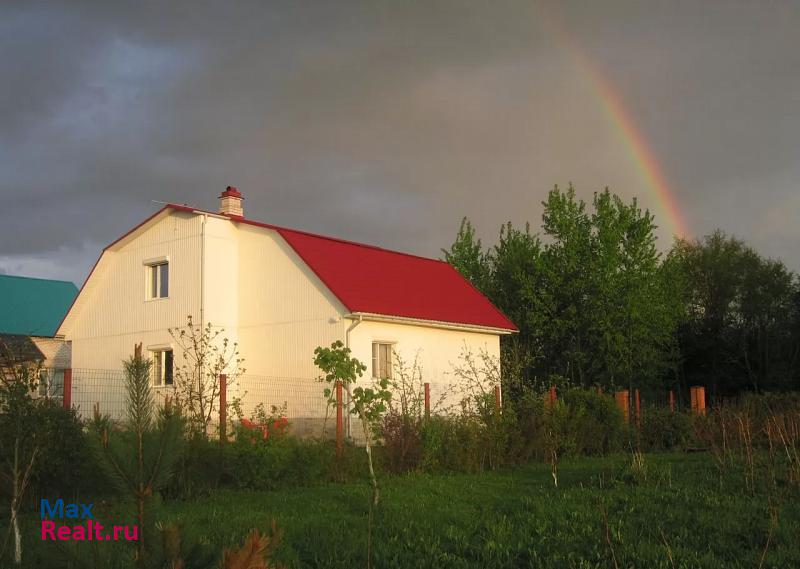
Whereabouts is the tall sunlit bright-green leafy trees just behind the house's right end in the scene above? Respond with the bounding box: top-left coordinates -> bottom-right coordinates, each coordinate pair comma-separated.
447,186 -> 683,395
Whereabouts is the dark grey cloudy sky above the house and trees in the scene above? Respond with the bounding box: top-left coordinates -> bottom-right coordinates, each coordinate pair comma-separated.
0,0 -> 800,285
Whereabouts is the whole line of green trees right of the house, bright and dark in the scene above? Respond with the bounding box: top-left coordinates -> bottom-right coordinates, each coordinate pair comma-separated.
442,186 -> 800,398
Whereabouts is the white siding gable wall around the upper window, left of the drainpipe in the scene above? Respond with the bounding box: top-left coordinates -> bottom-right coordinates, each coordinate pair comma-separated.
65,212 -> 201,416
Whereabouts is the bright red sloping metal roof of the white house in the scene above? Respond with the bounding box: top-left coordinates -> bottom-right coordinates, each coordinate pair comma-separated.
270,220 -> 517,331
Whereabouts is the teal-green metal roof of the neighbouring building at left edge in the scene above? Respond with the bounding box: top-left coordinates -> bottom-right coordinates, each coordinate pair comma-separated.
0,275 -> 78,336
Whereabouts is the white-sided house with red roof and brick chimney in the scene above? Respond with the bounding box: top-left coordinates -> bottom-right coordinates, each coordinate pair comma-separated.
58,187 -> 516,430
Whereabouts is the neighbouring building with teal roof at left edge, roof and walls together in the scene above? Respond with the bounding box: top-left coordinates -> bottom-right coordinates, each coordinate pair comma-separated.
0,275 -> 78,395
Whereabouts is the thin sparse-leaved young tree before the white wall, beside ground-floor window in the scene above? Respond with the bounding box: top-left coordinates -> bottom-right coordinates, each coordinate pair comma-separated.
169,315 -> 246,437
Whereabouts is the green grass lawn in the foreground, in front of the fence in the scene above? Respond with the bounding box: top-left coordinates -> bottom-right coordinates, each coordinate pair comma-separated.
10,454 -> 800,568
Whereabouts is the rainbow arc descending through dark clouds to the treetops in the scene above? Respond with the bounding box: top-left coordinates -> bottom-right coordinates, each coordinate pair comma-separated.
546,13 -> 690,237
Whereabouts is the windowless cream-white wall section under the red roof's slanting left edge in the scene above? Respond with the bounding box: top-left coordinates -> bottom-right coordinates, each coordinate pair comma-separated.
231,222 -> 347,434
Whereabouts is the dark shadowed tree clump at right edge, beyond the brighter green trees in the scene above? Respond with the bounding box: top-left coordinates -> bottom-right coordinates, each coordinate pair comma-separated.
670,230 -> 800,396
